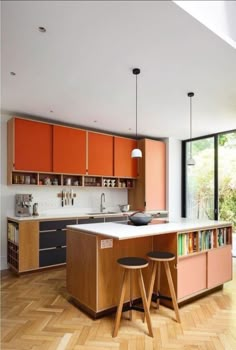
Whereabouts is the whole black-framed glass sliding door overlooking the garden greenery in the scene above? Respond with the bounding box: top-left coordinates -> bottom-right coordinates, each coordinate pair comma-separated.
182,130 -> 236,230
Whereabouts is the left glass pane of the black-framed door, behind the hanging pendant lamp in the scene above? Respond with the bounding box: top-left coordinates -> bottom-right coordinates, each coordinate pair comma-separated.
186,137 -> 214,219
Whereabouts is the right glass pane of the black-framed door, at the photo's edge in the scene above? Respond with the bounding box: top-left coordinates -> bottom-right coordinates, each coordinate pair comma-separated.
218,131 -> 236,229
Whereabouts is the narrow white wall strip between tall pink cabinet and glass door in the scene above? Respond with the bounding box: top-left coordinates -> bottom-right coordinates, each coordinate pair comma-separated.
167,138 -> 181,218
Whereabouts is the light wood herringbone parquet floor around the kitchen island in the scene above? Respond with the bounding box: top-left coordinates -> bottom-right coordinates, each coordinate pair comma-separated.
1,259 -> 236,350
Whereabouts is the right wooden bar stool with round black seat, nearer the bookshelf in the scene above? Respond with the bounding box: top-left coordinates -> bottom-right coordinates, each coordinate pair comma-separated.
147,251 -> 181,323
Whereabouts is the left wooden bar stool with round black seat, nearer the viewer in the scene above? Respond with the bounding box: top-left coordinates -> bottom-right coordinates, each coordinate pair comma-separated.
112,257 -> 153,337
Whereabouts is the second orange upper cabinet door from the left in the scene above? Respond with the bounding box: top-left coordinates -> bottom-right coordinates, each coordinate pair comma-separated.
53,125 -> 86,174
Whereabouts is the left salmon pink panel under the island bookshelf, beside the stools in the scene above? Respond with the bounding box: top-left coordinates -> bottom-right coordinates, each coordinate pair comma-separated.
177,253 -> 207,300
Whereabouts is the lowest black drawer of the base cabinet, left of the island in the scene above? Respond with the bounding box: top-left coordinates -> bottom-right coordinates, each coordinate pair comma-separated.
39,247 -> 66,267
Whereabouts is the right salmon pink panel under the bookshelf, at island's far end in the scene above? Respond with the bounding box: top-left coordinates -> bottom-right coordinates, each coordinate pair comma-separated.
207,245 -> 232,288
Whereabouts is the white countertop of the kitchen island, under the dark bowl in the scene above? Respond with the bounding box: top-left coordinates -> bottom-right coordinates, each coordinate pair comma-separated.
67,218 -> 232,240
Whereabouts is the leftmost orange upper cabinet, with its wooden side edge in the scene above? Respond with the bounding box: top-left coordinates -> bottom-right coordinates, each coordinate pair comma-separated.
12,118 -> 52,172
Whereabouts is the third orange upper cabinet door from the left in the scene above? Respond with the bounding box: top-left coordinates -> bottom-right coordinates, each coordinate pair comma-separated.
88,131 -> 113,176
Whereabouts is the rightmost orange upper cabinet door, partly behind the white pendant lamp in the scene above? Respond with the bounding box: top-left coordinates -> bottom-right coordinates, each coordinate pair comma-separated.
114,136 -> 137,177
